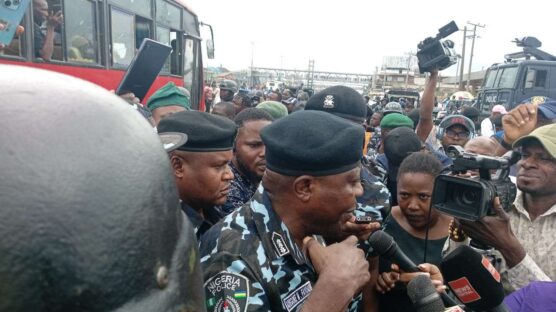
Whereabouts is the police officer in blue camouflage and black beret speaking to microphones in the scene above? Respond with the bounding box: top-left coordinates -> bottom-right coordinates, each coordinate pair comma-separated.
200,111 -> 378,311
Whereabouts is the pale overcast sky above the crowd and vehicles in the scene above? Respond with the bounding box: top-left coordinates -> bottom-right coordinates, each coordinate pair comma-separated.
187,0 -> 556,75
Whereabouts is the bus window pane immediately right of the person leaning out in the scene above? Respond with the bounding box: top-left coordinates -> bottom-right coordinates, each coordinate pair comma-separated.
64,0 -> 98,63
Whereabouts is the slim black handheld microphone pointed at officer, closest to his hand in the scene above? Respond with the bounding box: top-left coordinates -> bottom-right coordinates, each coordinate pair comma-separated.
369,230 -> 464,306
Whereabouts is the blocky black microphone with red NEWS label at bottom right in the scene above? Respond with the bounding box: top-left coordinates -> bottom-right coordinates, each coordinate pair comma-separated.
440,245 -> 509,312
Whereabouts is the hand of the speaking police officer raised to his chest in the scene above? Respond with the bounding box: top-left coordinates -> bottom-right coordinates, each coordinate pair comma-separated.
303,236 -> 371,296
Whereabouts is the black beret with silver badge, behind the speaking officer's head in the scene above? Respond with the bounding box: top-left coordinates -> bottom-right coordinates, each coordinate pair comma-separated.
305,86 -> 367,123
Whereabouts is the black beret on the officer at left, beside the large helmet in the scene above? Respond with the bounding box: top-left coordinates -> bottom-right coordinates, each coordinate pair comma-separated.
157,111 -> 237,152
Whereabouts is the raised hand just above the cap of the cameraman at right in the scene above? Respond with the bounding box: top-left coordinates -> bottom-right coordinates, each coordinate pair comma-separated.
502,103 -> 538,144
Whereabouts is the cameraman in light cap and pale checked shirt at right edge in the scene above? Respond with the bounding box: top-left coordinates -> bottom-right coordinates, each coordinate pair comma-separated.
460,124 -> 556,290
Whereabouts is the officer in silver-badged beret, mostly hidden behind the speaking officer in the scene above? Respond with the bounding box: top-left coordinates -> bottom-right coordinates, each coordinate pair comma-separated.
305,86 -> 390,220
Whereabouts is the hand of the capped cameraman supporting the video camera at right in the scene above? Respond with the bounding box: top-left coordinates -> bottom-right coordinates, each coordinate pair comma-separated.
459,197 -> 525,268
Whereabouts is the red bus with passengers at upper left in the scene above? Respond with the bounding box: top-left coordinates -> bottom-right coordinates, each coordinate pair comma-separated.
0,0 -> 214,110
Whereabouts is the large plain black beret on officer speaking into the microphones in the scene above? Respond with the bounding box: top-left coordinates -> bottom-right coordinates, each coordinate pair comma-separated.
261,111 -> 365,176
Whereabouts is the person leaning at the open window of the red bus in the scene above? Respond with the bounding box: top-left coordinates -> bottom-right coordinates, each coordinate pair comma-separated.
33,0 -> 64,61
